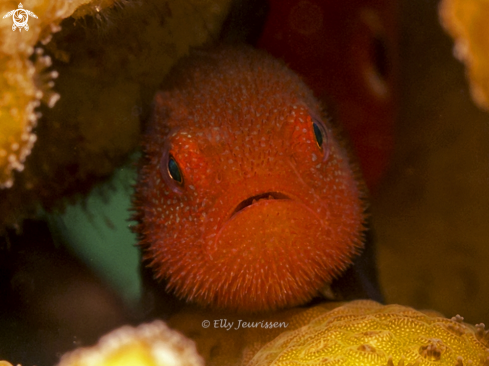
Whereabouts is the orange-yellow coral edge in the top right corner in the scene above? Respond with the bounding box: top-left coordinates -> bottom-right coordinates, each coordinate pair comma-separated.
440,0 -> 489,110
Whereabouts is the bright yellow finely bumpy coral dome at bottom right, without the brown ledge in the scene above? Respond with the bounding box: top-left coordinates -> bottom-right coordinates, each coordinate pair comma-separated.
248,301 -> 489,366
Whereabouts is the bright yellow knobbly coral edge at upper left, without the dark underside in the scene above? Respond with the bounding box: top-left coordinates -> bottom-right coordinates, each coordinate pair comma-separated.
0,0 -> 95,188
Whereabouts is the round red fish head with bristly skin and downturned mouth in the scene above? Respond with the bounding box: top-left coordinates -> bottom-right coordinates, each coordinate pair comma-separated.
135,48 -> 364,311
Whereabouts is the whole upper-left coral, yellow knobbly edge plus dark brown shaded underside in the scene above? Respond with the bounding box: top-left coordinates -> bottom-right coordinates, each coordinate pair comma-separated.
0,0 -> 230,229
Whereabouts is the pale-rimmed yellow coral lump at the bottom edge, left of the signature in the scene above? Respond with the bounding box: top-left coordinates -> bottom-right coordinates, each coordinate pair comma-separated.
58,321 -> 204,366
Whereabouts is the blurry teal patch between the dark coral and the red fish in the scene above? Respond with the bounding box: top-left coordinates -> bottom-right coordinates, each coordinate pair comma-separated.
48,165 -> 142,305
